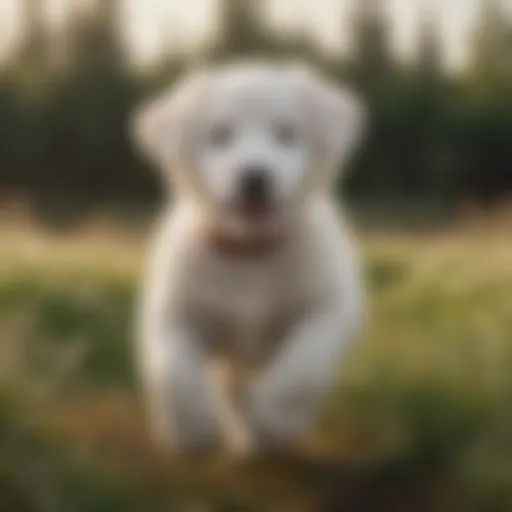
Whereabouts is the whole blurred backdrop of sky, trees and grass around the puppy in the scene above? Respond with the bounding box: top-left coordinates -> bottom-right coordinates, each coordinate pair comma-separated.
0,0 -> 512,512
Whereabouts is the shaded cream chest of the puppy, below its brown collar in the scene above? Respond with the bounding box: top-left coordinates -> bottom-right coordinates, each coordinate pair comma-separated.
189,256 -> 293,365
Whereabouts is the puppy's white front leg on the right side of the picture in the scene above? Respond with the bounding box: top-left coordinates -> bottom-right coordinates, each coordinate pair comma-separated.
251,303 -> 357,445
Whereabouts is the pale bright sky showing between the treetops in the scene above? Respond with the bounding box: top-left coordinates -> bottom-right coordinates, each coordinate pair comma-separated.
0,0 -> 512,67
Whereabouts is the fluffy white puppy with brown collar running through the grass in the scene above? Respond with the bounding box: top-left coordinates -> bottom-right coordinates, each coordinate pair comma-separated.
132,63 -> 364,452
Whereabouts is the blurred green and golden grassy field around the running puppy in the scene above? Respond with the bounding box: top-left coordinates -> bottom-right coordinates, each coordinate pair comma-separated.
0,218 -> 512,512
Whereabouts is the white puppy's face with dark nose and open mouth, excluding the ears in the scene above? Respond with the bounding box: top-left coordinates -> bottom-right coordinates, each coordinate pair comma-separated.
195,72 -> 314,223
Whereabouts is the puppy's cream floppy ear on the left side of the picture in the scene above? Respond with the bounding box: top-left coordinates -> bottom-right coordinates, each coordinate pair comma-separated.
132,71 -> 206,172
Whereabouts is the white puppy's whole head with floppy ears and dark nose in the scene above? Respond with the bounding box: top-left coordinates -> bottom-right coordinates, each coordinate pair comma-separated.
135,64 -> 364,234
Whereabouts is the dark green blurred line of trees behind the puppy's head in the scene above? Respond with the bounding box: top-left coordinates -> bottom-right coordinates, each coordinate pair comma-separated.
0,0 -> 512,218
